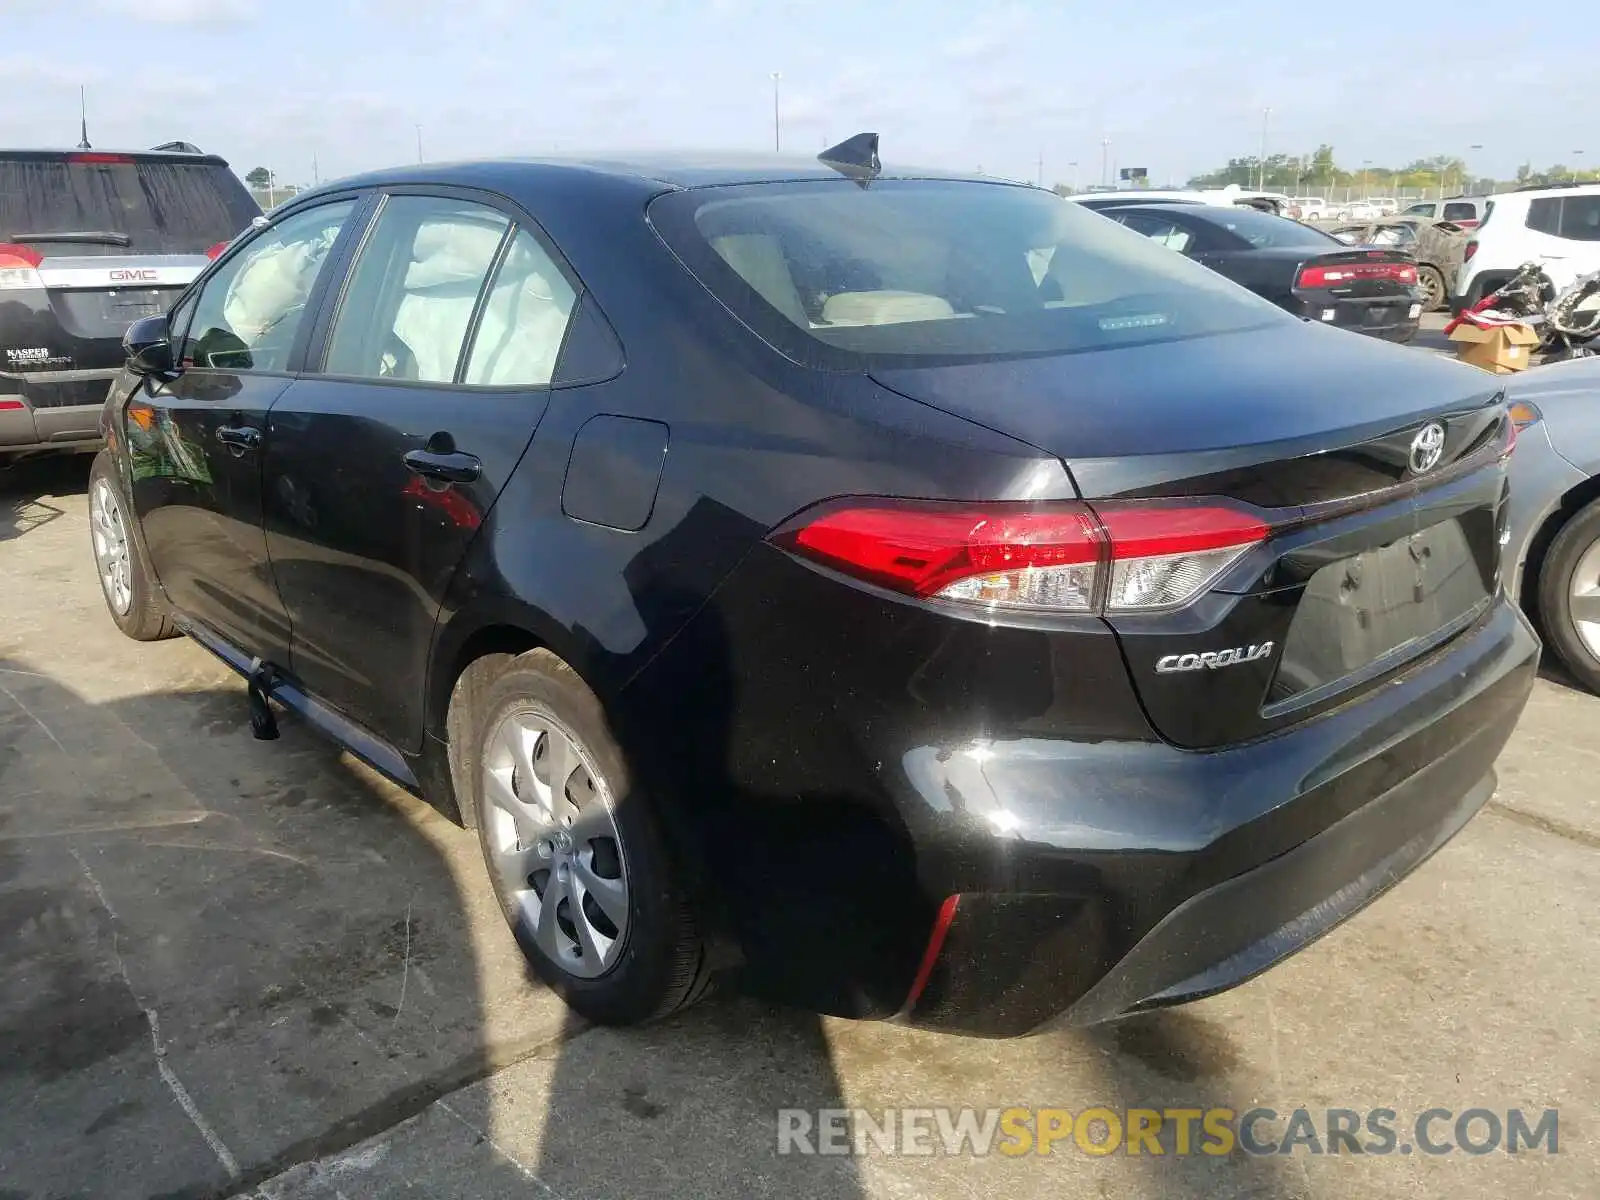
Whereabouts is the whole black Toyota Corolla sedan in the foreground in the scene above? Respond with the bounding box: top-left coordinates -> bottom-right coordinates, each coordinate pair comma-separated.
90,136 -> 1538,1034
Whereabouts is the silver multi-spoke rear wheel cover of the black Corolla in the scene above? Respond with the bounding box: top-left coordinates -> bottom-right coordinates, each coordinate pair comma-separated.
483,707 -> 629,979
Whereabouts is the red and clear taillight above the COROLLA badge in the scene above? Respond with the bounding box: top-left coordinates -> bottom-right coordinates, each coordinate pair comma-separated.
773,501 -> 1269,613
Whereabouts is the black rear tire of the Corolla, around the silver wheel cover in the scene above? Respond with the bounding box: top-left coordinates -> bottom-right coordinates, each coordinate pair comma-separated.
464,650 -> 712,1026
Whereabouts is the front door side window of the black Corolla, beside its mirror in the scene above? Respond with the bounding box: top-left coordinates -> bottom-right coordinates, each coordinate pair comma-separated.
182,200 -> 355,371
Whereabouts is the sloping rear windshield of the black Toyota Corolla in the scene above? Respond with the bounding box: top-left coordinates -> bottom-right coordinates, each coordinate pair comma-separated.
650,179 -> 1290,370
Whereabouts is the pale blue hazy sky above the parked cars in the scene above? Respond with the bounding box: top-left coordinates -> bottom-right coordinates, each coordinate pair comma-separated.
0,0 -> 1600,186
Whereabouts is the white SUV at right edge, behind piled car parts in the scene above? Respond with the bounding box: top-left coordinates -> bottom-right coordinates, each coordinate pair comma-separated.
1453,184 -> 1600,309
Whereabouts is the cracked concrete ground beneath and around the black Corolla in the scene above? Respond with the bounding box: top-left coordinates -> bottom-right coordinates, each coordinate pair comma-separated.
0,462 -> 1600,1200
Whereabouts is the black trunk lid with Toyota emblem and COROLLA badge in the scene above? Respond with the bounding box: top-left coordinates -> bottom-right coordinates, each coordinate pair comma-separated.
875,325 -> 1509,749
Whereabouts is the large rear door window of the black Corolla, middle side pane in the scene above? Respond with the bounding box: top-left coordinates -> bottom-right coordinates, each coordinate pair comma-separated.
323,195 -> 510,384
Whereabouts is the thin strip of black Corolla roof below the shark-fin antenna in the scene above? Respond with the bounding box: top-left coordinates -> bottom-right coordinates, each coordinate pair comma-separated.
321,152 -> 985,189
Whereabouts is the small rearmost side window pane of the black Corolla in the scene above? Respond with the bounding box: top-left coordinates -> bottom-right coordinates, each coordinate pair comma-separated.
466,229 -> 576,387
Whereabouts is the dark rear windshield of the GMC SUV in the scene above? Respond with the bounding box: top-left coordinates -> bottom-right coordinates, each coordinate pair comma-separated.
0,155 -> 261,254
